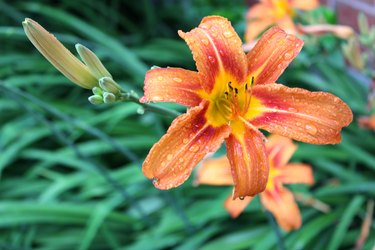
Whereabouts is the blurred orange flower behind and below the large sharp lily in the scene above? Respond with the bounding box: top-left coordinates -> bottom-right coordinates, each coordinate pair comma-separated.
196,135 -> 314,231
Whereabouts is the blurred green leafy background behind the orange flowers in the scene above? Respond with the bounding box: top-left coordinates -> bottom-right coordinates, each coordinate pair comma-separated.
0,0 -> 375,250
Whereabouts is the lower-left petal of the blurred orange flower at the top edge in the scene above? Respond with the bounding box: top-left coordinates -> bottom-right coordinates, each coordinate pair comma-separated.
245,3 -> 275,43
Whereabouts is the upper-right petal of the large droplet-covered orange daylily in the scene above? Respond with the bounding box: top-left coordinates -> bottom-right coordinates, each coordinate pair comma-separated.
247,27 -> 303,84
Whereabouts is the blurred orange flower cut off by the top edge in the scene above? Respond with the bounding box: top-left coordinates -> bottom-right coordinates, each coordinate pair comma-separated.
245,0 -> 319,43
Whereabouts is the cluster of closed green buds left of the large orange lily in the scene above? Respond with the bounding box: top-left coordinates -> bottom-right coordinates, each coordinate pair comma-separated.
22,18 -> 123,105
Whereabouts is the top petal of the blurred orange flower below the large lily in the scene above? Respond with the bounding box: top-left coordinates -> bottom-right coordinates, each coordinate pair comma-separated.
266,135 -> 297,168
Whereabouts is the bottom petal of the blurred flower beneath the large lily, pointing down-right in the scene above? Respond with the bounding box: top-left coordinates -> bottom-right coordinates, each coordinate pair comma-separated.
260,188 -> 302,231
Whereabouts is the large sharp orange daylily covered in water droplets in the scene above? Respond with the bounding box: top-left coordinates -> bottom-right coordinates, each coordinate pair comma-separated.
141,16 -> 352,198
